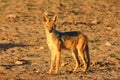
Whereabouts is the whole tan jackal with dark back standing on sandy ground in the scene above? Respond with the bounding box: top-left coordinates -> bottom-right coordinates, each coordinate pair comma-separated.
43,13 -> 90,74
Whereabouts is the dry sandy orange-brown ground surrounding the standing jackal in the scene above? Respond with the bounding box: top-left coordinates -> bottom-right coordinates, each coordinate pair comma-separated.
0,0 -> 120,80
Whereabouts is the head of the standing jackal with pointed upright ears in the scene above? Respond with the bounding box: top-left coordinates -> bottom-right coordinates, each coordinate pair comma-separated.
43,13 -> 57,33
